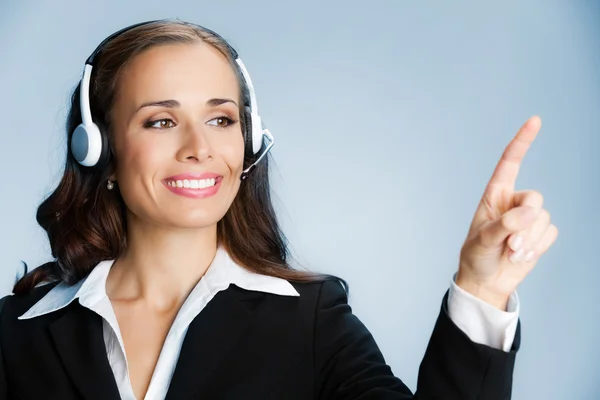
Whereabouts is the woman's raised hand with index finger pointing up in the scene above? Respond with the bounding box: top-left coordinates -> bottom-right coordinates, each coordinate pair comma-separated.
456,116 -> 558,311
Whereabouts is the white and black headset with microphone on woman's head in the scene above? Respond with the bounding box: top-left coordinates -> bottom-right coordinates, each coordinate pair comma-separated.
70,20 -> 275,181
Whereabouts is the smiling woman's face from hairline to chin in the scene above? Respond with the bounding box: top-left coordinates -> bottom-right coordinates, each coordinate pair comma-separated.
111,43 -> 244,228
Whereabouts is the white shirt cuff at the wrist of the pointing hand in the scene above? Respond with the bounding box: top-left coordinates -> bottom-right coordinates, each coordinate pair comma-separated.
448,274 -> 520,352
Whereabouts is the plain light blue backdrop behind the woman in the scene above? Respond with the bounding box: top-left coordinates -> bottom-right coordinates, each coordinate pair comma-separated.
0,0 -> 600,400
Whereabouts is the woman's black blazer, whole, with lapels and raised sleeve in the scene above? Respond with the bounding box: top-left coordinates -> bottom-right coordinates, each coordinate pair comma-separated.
0,281 -> 520,400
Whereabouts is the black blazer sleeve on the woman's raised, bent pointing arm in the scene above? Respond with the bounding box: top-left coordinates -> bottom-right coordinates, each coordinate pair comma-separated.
314,281 -> 520,400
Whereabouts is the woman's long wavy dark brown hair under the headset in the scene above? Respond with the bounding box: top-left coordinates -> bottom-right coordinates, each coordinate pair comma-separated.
13,20 -> 348,294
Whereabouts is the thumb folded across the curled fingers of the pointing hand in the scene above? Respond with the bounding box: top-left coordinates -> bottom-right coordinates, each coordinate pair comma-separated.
479,206 -> 540,248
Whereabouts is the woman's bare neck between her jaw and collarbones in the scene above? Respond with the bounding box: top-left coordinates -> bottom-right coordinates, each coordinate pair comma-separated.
106,211 -> 217,310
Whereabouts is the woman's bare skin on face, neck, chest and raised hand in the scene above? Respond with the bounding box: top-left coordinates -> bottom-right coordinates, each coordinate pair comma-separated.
99,43 -> 558,398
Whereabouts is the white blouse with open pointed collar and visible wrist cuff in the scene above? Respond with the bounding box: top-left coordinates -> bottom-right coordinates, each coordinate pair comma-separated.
19,247 -> 519,400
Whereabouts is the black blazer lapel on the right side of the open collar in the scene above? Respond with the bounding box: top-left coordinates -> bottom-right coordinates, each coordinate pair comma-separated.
165,284 -> 264,400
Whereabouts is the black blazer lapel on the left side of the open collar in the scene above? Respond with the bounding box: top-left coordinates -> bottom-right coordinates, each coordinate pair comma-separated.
50,302 -> 120,400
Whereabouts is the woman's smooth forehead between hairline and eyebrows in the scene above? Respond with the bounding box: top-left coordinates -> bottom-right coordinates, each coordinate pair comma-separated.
117,42 -> 239,104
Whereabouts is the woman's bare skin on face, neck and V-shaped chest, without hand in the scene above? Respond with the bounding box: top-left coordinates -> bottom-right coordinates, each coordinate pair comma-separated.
106,43 -> 244,398
